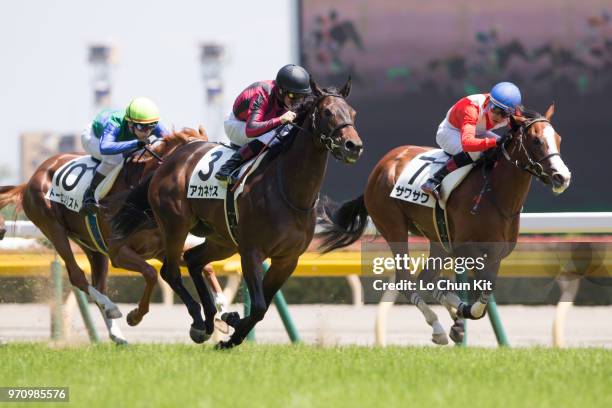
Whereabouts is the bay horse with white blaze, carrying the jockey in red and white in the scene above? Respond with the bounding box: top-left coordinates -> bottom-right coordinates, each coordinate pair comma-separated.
319,105 -> 571,344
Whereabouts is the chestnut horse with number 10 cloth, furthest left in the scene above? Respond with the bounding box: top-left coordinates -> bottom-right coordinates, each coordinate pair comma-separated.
0,127 -> 212,344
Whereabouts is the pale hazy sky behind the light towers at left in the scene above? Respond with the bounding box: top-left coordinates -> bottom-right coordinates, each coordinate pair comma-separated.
0,0 -> 298,184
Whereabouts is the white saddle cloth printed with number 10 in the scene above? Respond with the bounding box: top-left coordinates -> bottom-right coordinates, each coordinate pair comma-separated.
45,156 -> 123,212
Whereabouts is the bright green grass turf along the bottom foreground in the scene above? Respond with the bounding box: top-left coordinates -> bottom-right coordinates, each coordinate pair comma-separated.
0,344 -> 612,408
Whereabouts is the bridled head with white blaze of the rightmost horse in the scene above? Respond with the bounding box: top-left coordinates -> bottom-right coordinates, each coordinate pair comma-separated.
501,105 -> 572,194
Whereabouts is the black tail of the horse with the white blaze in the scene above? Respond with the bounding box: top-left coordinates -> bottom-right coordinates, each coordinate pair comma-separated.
317,195 -> 368,253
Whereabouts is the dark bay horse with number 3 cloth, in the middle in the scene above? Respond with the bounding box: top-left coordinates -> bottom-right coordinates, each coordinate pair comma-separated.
113,78 -> 363,348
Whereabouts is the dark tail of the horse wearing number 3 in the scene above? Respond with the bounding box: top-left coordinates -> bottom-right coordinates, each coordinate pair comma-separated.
110,173 -> 157,239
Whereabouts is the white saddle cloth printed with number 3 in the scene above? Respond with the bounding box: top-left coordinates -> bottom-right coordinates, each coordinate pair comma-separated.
187,145 -> 267,200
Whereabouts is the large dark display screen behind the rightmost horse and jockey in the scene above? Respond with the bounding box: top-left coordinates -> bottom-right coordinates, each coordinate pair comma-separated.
301,0 -> 612,211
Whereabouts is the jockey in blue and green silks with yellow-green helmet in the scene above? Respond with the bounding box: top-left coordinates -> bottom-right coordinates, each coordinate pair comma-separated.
81,97 -> 168,213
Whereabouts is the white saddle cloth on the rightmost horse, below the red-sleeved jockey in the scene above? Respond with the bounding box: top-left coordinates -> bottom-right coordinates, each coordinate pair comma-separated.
390,149 -> 474,209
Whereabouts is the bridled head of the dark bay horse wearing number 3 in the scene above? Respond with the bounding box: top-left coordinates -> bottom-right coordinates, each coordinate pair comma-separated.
298,78 -> 363,164
